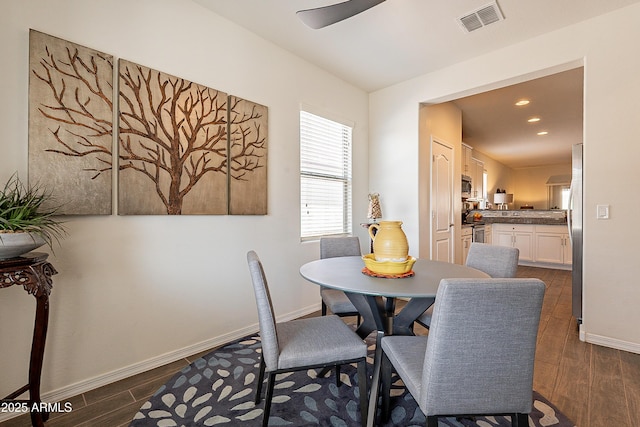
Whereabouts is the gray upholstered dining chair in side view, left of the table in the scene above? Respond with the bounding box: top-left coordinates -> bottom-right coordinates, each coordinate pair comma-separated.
247,251 -> 368,426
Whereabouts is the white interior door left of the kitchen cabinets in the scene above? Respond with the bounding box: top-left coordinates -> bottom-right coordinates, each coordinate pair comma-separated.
431,139 -> 454,263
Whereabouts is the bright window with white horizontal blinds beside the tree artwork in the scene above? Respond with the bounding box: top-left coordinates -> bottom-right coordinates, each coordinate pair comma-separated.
300,111 -> 352,240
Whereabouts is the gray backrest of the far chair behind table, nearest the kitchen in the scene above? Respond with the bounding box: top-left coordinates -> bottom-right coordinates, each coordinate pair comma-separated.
465,242 -> 520,278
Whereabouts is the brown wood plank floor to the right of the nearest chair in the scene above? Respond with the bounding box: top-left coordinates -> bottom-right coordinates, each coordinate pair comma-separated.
518,267 -> 640,427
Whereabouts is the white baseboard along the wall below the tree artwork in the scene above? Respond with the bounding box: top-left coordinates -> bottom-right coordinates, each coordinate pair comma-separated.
0,304 -> 320,422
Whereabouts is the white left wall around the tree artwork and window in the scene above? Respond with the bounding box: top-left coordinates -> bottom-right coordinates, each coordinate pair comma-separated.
0,0 -> 369,404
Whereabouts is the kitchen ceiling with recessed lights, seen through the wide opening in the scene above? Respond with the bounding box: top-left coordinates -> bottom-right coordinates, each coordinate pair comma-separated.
452,67 -> 584,168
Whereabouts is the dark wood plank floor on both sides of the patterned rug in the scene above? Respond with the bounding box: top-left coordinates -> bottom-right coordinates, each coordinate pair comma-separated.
0,267 -> 640,427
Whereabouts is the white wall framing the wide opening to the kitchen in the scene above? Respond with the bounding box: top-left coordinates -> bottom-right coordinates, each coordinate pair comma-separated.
369,5 -> 640,353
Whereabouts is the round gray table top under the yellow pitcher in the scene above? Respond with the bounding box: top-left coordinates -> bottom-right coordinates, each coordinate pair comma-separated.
300,256 -> 489,298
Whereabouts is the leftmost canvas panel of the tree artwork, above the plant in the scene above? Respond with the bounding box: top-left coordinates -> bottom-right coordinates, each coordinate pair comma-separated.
29,30 -> 113,215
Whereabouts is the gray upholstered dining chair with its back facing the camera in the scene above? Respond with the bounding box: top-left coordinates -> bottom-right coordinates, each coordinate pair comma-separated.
381,278 -> 545,427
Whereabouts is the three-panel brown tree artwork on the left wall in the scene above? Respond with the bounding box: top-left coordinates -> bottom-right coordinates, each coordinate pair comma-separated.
29,30 -> 268,215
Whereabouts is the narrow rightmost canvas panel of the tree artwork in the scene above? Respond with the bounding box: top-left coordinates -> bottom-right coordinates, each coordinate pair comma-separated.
229,96 -> 268,215
